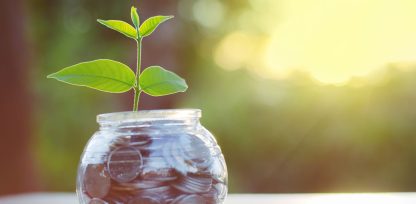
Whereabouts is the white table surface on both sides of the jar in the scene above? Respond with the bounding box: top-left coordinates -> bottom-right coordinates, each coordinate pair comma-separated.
0,193 -> 416,204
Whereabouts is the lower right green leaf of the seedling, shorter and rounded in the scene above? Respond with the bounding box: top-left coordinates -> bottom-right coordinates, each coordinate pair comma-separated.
139,66 -> 188,96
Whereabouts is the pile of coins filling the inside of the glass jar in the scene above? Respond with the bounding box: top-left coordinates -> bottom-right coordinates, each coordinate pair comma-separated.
81,131 -> 227,204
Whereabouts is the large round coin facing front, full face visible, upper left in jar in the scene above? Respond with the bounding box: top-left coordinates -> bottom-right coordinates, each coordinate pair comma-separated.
107,147 -> 142,183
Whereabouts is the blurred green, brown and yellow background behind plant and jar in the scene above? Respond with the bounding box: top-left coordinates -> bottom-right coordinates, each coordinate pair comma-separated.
0,0 -> 416,194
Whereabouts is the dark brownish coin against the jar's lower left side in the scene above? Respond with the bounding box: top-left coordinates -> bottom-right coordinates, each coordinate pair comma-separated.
83,164 -> 111,198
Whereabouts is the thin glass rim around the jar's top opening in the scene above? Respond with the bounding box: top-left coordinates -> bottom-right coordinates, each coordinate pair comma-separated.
97,109 -> 201,124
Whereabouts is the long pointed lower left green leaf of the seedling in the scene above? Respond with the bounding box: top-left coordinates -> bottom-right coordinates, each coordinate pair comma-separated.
48,59 -> 135,93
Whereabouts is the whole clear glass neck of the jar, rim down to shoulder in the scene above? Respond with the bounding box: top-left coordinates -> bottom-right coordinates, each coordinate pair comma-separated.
97,109 -> 201,129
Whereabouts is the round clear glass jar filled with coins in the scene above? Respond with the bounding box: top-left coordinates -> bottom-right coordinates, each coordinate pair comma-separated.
77,109 -> 227,204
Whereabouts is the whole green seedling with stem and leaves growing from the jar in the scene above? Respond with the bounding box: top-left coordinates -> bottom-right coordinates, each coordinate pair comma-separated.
48,7 -> 188,111
